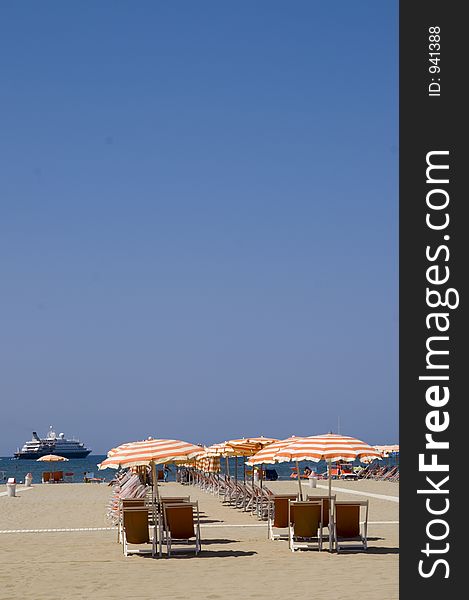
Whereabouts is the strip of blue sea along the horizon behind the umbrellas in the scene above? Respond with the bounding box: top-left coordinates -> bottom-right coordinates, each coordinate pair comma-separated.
0,454 -> 398,484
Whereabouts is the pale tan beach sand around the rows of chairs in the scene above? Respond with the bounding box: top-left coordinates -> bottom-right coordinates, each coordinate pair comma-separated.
0,480 -> 399,600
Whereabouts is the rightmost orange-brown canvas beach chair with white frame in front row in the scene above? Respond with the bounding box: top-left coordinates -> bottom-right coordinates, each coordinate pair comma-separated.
333,500 -> 368,552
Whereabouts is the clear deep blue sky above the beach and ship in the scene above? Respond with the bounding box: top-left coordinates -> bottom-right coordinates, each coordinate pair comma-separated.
0,0 -> 398,456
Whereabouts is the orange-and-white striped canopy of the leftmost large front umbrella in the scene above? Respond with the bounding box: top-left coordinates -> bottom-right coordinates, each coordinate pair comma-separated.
98,438 -> 204,469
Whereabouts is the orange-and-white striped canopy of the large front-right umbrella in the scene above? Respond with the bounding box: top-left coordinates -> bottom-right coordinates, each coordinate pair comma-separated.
276,433 -> 381,462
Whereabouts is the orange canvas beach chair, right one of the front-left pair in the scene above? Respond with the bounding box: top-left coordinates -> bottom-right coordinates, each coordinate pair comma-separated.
163,502 -> 201,556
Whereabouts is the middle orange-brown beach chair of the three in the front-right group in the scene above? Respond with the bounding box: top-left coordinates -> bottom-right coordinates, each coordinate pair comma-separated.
288,500 -> 323,552
